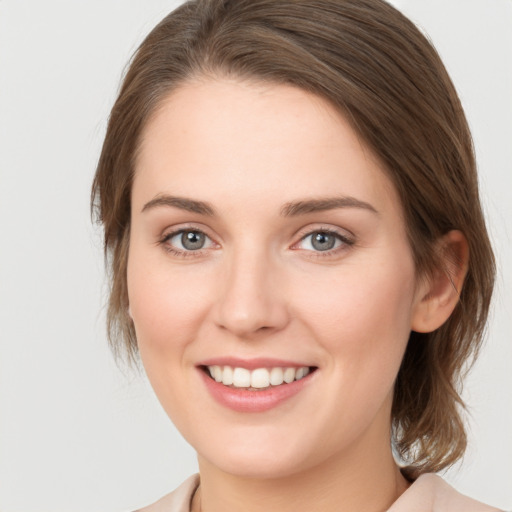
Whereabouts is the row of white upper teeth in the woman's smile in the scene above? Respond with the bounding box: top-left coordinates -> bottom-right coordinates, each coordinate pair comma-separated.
208,365 -> 309,389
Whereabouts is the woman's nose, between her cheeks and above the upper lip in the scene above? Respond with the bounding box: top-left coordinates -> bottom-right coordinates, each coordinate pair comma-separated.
215,245 -> 289,339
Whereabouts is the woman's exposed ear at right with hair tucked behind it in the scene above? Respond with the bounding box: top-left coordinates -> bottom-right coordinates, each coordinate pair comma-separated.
411,230 -> 469,332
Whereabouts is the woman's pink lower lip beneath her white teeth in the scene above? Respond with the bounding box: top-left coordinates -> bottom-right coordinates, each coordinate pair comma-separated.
199,369 -> 313,412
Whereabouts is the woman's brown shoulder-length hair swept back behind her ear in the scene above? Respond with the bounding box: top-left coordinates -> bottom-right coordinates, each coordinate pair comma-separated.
92,0 -> 495,476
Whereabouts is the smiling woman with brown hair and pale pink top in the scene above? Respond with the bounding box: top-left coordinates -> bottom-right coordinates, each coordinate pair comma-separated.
93,0 -> 504,512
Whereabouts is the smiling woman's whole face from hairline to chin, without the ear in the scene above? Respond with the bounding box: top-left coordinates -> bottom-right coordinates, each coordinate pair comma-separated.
128,79 -> 421,477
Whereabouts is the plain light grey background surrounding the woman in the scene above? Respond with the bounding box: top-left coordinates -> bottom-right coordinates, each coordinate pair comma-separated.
0,0 -> 512,512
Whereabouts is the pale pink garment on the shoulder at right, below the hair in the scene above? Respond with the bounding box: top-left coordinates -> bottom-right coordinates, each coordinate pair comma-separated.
388,473 -> 499,512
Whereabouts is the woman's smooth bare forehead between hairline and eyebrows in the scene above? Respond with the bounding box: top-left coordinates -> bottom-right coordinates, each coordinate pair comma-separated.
133,79 -> 398,217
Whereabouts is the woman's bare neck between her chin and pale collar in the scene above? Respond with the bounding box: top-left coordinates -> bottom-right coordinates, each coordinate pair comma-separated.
193,436 -> 408,512
